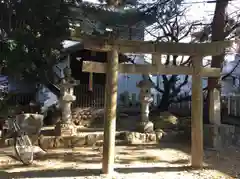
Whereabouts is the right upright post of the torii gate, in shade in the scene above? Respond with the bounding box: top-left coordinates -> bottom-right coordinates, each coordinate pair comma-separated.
191,57 -> 203,167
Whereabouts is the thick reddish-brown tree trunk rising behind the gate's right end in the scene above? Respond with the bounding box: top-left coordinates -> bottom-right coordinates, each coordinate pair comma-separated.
204,0 -> 229,123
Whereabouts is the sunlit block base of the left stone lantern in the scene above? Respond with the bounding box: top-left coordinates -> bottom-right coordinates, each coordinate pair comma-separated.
55,123 -> 77,136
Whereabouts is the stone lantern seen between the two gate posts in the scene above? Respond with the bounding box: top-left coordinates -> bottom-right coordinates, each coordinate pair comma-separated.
137,79 -> 154,133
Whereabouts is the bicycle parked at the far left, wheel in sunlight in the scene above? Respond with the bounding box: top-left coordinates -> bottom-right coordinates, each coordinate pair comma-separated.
3,117 -> 33,165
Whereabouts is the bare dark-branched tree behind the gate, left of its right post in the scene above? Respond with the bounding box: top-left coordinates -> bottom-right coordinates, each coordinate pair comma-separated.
144,8 -> 199,111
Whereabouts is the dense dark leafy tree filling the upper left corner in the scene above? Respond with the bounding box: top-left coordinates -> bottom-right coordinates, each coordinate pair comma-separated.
0,0 -> 69,81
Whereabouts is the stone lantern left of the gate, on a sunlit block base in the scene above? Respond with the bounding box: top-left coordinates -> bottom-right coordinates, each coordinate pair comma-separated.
56,67 -> 78,136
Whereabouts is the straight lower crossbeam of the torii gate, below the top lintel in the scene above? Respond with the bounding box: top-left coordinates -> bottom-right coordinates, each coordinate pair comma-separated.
82,60 -> 221,77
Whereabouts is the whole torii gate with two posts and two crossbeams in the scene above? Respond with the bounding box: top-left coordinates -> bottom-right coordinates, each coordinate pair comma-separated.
72,33 -> 231,174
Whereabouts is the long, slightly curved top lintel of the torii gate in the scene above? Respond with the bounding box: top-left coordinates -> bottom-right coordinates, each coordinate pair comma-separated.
71,31 -> 232,56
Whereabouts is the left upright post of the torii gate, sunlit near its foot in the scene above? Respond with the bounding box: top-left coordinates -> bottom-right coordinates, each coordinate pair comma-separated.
102,50 -> 118,174
